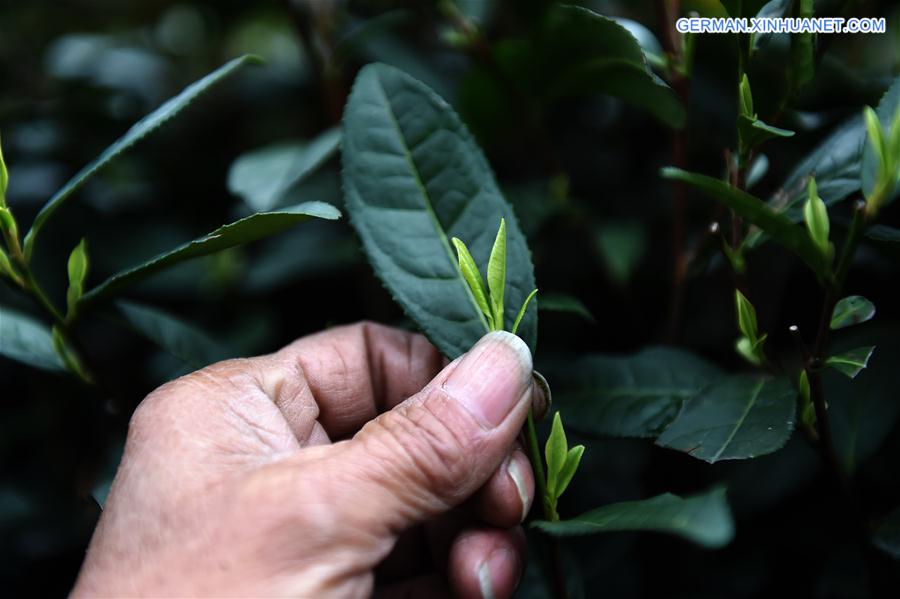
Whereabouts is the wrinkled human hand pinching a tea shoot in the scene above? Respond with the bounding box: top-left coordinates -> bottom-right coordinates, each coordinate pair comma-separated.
73,323 -> 544,597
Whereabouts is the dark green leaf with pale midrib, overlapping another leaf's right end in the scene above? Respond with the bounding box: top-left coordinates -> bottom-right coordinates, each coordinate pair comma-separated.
656,375 -> 797,463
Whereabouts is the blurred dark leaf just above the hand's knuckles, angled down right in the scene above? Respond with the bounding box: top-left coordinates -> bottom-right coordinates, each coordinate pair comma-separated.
116,301 -> 230,368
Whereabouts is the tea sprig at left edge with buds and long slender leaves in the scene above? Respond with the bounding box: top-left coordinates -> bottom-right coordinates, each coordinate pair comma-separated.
0,56 -> 339,385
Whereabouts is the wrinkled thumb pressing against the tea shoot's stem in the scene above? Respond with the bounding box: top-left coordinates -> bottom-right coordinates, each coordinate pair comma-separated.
331,331 -> 533,535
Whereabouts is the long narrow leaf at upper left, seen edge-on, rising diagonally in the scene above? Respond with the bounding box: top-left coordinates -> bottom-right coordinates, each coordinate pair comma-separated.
25,55 -> 260,256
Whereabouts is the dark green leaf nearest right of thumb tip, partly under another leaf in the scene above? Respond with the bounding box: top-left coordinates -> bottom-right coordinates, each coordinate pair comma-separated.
553,347 -> 722,437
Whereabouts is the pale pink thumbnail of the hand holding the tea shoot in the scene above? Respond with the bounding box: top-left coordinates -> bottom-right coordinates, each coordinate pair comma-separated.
444,331 -> 532,428
